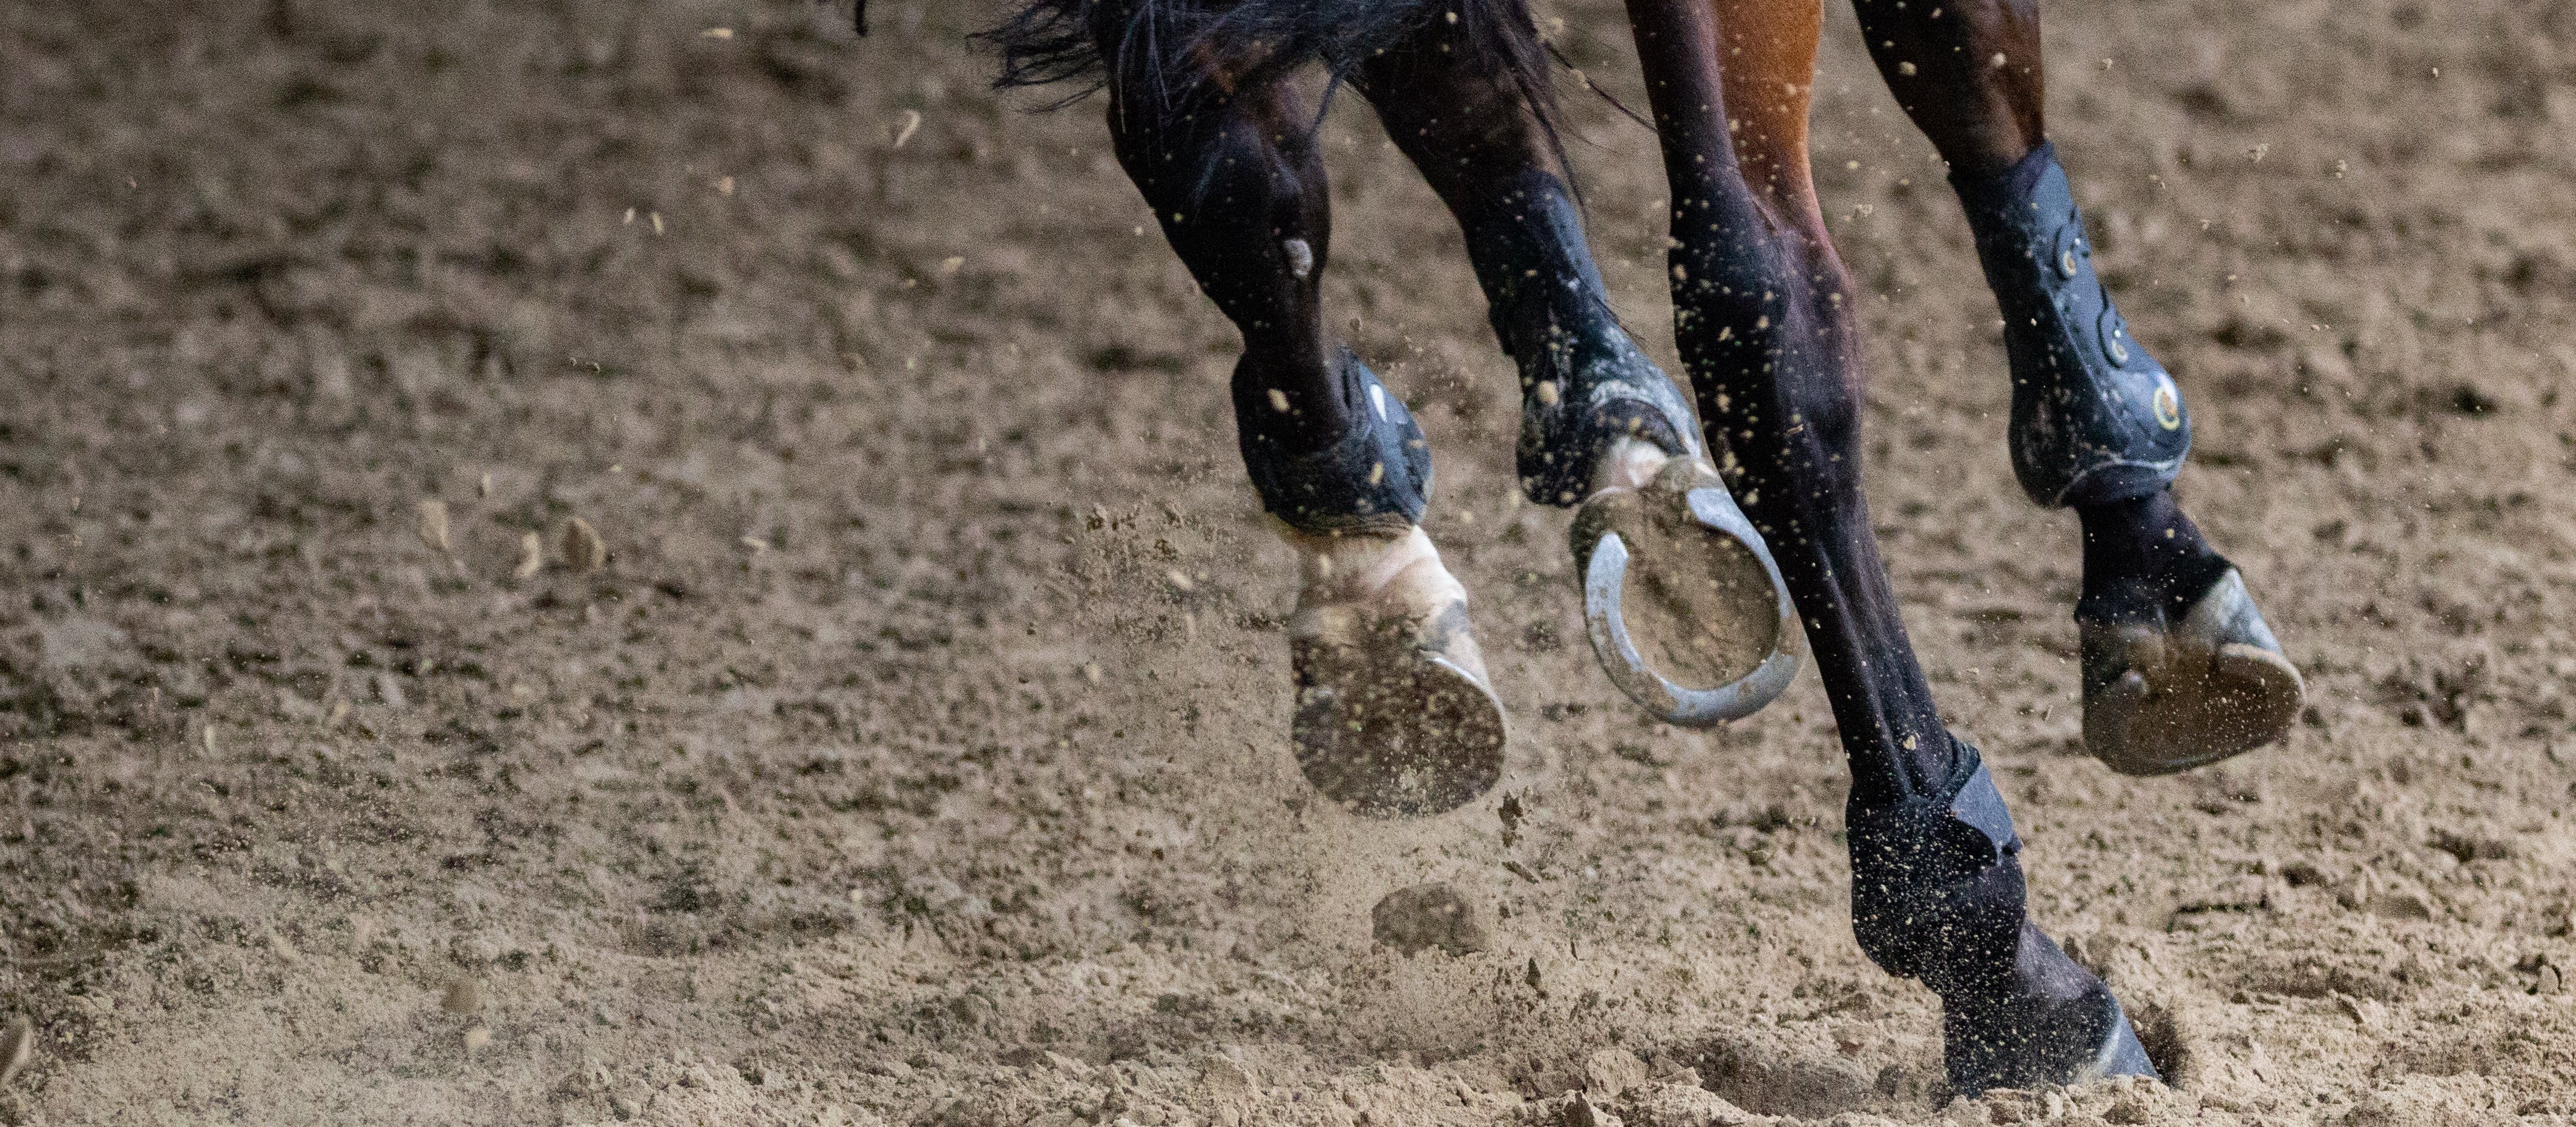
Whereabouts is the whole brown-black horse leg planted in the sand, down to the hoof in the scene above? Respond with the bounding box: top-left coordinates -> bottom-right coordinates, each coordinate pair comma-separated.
1628,0 -> 2154,1094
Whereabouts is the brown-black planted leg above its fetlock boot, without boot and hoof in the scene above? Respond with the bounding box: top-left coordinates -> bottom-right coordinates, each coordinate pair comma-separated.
1628,0 -> 1958,806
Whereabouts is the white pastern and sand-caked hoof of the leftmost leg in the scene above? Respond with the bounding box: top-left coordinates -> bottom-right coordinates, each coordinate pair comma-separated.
1288,540 -> 1507,818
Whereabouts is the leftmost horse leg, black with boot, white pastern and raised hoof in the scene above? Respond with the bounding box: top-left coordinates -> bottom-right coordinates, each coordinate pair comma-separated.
1092,5 -> 1505,816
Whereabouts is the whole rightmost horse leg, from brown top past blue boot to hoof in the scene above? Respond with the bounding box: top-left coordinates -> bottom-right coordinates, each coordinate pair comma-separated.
1855,0 -> 2305,775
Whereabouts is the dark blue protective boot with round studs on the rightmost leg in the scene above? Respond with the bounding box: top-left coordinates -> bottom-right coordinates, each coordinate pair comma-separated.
1953,144 -> 2192,507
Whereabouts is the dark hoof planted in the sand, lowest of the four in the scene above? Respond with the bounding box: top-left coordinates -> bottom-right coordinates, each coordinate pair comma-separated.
1942,921 -> 2161,1096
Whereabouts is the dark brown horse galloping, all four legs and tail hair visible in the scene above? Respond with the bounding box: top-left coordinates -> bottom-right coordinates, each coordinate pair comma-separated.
958,0 -> 2305,1094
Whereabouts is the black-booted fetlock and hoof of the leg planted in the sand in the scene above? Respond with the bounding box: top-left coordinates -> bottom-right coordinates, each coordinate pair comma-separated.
1847,744 -> 2156,1096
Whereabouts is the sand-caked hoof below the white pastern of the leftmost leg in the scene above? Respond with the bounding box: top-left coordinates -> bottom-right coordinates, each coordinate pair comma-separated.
1290,610 -> 1505,818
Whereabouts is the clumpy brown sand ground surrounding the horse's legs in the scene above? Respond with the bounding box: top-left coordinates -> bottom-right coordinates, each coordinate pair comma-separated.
0,0 -> 2576,1125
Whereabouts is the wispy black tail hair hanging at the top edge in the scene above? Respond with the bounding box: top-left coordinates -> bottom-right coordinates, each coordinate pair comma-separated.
976,0 -> 1561,142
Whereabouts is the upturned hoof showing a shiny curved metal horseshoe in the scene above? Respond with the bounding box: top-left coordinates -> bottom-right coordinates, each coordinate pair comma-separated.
1574,458 -> 1803,728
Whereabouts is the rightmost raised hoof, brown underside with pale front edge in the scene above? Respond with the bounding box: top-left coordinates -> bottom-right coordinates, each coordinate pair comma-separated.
2082,569 -> 2305,775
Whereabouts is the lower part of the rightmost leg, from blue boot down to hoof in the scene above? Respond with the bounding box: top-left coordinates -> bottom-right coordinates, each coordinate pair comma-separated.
1955,144 -> 2305,775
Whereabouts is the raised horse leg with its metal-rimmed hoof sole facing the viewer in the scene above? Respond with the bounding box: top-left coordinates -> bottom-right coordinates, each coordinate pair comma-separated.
1358,35 -> 1798,726
